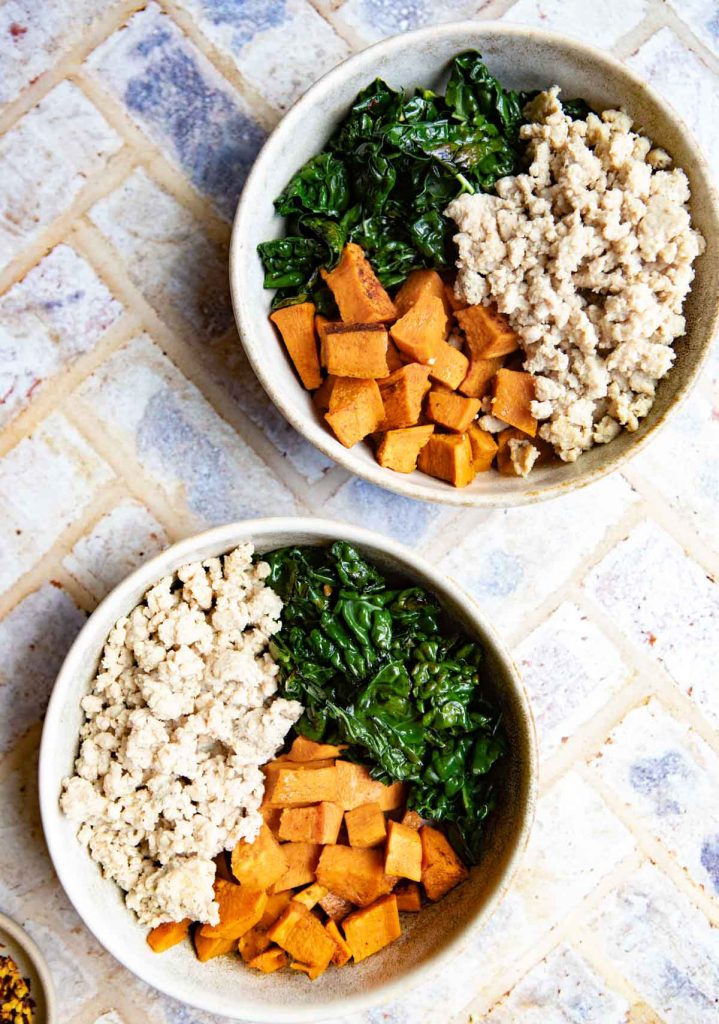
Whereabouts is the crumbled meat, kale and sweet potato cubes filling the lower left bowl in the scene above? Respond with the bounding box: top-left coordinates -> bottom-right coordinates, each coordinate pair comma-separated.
60,542 -> 511,980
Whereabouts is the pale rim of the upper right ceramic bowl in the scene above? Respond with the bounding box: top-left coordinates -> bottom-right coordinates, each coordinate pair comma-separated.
228,19 -> 719,508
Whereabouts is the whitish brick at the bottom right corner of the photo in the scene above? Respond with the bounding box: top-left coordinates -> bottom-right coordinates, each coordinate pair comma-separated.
588,864 -> 719,1024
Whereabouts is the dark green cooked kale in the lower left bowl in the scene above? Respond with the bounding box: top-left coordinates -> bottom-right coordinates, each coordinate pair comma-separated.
262,542 -> 507,862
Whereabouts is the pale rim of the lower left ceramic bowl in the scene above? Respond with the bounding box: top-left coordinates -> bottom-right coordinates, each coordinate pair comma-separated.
38,516 -> 539,1024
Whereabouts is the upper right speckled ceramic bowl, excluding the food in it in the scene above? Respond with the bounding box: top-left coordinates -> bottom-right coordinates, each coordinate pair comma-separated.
229,22 -> 719,507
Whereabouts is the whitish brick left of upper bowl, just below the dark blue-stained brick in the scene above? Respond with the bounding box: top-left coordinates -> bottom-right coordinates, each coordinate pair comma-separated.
89,169 -> 232,338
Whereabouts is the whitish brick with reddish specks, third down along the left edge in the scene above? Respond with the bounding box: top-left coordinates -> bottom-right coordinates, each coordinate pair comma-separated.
0,245 -> 122,427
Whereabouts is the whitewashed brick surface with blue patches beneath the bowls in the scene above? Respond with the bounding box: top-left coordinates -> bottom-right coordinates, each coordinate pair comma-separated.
0,0 -> 719,1024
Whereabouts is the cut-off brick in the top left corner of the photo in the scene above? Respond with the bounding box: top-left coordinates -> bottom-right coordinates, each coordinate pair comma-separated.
0,0 -> 108,104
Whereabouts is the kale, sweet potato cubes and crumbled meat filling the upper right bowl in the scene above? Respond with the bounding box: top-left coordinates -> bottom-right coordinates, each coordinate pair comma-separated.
259,51 -> 705,486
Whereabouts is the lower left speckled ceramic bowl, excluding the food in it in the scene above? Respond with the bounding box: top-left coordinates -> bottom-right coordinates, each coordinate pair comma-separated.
40,518 -> 538,1024
